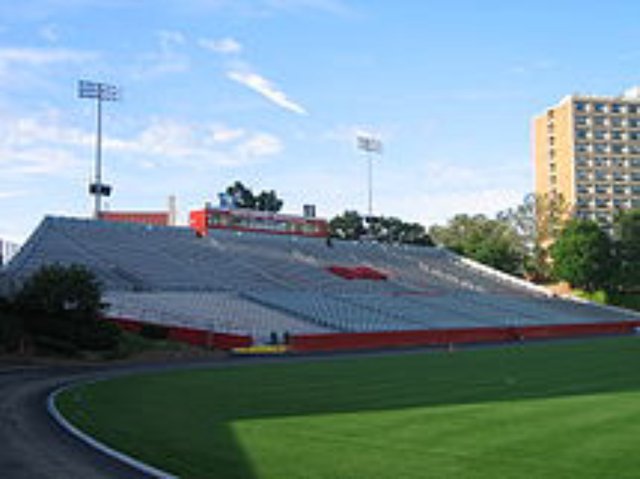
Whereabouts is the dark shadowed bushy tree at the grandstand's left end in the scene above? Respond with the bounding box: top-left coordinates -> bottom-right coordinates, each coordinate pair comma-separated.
14,264 -> 119,352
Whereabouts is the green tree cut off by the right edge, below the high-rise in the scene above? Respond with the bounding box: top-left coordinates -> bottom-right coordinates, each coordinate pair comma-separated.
613,209 -> 640,290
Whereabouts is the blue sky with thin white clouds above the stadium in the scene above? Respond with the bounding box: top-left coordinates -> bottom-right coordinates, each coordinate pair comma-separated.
0,0 -> 640,241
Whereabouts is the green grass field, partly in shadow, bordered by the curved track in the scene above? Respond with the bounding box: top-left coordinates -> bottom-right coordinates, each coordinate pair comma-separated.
58,337 -> 640,479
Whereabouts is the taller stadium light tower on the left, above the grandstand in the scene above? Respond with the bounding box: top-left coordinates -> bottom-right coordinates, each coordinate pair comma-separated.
78,80 -> 120,219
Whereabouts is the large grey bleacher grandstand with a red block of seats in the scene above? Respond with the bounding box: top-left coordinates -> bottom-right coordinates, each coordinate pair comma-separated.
3,217 -> 640,349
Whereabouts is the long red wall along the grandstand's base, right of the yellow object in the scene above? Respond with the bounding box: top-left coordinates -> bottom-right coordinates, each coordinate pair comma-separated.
289,321 -> 640,352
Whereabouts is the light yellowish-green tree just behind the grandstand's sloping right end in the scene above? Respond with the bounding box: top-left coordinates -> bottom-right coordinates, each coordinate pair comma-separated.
429,214 -> 525,274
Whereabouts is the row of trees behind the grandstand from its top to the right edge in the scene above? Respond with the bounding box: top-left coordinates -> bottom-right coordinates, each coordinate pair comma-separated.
329,194 -> 640,292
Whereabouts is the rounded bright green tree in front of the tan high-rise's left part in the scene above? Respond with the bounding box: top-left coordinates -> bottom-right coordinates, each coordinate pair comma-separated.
551,220 -> 616,292
